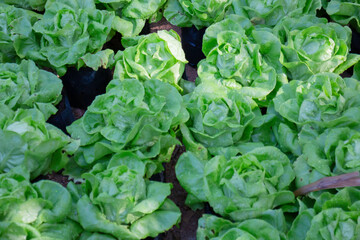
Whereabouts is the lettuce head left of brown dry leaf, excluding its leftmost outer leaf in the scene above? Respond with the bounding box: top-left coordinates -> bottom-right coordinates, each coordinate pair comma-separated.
204,147 -> 295,221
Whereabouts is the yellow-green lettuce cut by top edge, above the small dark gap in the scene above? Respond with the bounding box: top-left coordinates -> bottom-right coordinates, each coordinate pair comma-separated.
164,0 -> 231,29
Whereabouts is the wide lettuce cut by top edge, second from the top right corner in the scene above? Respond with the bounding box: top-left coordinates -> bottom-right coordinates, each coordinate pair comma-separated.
228,0 -> 321,27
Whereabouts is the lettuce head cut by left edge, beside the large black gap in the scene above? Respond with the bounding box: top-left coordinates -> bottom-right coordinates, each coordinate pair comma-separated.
0,60 -> 63,120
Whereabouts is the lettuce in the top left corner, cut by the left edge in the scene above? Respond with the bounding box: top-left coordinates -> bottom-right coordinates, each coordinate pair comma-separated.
0,1 -> 46,63
